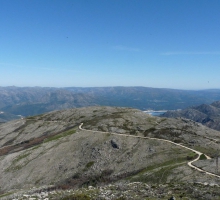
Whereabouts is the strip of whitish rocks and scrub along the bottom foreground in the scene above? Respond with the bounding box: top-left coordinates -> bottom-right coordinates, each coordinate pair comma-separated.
0,182 -> 220,200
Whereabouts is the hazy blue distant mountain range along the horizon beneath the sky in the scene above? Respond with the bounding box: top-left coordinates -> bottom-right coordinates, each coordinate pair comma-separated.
0,87 -> 220,120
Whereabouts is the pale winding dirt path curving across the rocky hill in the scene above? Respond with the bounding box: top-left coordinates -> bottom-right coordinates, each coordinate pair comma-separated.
79,123 -> 220,178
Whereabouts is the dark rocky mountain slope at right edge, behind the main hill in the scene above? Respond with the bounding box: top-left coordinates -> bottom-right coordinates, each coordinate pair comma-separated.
161,101 -> 220,130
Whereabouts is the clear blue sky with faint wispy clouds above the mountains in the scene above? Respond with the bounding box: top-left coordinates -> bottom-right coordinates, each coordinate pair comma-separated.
0,0 -> 220,89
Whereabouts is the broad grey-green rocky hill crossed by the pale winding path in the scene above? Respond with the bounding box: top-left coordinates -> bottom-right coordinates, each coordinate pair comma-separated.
0,106 -> 220,199
